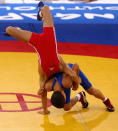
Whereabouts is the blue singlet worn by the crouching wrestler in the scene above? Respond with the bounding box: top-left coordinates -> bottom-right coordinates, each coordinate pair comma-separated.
52,63 -> 92,104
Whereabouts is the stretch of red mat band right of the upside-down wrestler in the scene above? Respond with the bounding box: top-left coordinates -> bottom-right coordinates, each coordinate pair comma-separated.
58,43 -> 118,59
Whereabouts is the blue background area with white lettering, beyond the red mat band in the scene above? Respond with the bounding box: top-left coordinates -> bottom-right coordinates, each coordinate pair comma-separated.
0,4 -> 118,45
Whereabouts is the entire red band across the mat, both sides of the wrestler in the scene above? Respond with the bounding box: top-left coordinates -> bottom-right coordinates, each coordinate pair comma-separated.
0,41 -> 118,59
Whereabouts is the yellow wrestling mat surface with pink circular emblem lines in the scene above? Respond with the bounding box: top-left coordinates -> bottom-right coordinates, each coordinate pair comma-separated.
0,52 -> 118,131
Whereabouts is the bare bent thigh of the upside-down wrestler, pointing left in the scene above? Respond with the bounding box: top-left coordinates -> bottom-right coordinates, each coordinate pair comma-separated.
6,26 -> 32,42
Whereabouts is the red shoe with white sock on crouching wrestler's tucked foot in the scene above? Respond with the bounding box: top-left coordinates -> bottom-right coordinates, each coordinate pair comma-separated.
79,91 -> 88,108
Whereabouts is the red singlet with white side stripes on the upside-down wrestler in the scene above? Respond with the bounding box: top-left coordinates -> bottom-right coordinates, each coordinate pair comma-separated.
29,27 -> 60,77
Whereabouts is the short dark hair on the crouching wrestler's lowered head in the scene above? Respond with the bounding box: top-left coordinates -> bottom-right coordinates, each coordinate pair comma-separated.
51,91 -> 65,108
